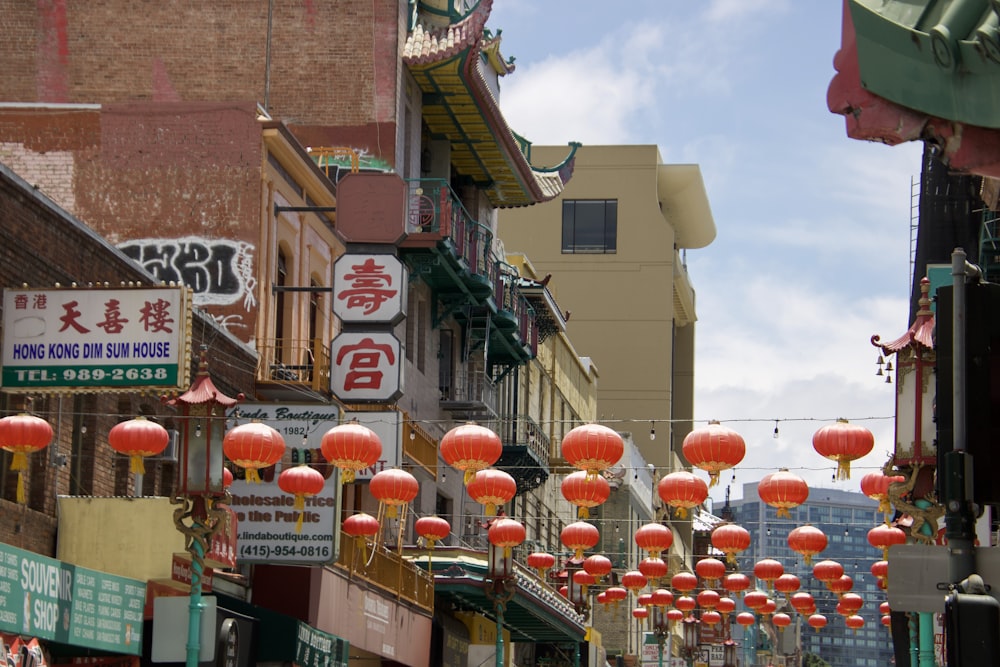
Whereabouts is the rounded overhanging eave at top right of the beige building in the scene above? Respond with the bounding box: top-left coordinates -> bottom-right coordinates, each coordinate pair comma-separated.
656,164 -> 716,248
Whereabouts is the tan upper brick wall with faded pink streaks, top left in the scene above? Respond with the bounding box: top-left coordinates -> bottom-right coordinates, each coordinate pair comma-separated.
0,0 -> 408,164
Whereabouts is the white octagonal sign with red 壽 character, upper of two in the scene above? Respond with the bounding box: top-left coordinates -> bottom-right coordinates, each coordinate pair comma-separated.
333,254 -> 406,324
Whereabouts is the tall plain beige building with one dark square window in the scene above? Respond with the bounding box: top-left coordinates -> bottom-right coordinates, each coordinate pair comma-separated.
499,145 -> 715,468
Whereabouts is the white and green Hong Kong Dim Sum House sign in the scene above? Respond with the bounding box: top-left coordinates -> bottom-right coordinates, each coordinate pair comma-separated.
0,287 -> 190,391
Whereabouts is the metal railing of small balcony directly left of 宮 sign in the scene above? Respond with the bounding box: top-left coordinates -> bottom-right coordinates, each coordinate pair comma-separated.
257,338 -> 330,392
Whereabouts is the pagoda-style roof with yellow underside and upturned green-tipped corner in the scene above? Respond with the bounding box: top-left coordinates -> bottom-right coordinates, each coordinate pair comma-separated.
403,0 -> 576,208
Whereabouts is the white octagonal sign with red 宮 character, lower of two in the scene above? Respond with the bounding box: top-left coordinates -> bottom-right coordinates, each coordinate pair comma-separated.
330,331 -> 403,403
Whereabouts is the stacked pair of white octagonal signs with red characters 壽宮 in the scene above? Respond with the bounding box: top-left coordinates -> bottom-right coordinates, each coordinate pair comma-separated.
330,253 -> 406,403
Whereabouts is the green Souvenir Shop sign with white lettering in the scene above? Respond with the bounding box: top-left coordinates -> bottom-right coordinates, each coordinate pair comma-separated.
0,544 -> 146,655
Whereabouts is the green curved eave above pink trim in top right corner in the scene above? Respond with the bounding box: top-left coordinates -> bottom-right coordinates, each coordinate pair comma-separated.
846,0 -> 1000,128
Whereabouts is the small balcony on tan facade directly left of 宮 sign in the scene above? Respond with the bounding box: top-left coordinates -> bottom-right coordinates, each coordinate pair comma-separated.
256,338 -> 330,401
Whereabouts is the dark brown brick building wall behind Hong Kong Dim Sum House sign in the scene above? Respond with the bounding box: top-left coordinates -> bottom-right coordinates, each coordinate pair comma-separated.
0,163 -> 255,556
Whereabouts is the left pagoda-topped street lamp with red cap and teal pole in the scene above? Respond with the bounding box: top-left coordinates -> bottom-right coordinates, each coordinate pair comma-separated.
166,349 -> 243,667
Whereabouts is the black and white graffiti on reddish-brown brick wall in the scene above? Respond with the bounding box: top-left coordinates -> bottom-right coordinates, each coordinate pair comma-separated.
118,236 -> 257,324
